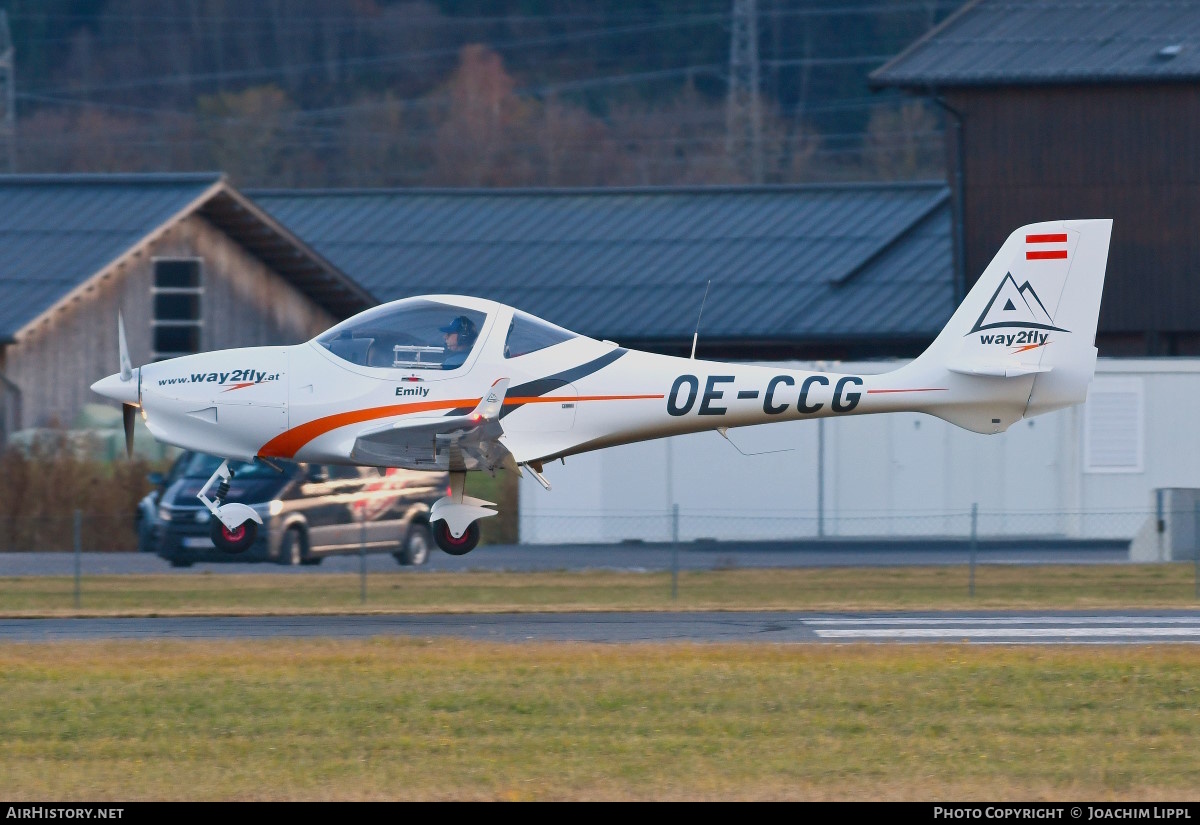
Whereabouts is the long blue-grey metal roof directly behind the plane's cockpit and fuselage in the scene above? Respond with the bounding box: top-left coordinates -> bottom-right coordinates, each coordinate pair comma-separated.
255,183 -> 954,344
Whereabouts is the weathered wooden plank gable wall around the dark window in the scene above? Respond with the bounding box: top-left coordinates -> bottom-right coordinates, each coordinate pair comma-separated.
5,215 -> 336,428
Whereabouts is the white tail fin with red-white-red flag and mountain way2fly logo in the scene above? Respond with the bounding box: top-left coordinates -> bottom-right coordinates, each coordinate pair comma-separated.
901,219 -> 1112,433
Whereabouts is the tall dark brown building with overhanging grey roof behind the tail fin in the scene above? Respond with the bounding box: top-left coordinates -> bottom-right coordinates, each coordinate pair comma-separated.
871,0 -> 1200,356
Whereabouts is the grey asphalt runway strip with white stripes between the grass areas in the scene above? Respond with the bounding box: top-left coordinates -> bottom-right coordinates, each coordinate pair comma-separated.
0,610 -> 1200,645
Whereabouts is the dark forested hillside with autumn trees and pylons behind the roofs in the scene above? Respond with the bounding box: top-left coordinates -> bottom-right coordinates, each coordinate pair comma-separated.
0,0 -> 960,187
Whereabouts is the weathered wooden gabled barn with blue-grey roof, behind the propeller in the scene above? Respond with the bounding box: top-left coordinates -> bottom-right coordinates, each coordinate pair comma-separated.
0,174 -> 374,441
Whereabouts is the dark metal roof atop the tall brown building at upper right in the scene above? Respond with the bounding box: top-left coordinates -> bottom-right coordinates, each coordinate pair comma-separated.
870,0 -> 1200,86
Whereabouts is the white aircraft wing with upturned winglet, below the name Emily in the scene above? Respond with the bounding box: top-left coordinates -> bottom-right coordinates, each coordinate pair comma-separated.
350,378 -> 515,472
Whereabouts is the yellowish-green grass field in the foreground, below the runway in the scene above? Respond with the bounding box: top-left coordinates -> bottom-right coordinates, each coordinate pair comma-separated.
0,639 -> 1200,802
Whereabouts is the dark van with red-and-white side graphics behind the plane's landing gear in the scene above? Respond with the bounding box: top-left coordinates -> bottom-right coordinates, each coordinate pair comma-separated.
157,452 -> 449,567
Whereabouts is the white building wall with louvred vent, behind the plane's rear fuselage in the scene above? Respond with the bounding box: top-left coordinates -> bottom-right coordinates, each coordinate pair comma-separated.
518,359 -> 1200,543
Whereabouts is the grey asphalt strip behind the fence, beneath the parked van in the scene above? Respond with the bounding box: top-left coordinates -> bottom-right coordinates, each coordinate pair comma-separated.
0,540 -> 1129,577
